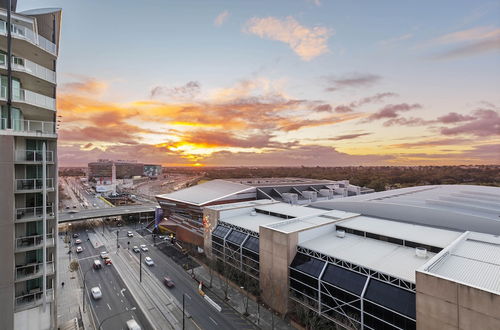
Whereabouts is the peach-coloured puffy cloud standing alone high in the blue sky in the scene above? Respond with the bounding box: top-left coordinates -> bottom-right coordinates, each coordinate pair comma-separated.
244,16 -> 333,61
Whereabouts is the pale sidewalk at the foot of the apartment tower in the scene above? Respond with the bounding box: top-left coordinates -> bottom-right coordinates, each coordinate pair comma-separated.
56,235 -> 95,329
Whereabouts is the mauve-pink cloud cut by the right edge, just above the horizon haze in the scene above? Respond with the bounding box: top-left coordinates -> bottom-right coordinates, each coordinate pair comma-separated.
440,109 -> 500,137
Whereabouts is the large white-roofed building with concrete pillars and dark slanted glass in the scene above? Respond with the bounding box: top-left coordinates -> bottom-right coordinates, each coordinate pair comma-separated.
200,186 -> 500,329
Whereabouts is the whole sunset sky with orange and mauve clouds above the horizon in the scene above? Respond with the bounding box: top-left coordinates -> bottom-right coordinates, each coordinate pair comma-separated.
18,0 -> 500,166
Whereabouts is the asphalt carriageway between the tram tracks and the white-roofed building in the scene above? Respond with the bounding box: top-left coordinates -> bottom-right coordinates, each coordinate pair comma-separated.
114,226 -> 256,330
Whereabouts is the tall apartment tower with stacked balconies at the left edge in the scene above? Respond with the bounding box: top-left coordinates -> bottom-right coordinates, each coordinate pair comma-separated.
0,0 -> 61,329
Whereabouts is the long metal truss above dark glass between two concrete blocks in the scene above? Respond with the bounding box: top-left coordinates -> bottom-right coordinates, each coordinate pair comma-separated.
297,246 -> 416,292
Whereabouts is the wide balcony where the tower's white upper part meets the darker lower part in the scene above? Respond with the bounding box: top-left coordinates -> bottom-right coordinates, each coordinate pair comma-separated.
0,118 -> 57,138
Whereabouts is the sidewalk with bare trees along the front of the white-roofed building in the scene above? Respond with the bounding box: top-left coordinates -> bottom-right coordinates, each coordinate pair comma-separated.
194,261 -> 292,330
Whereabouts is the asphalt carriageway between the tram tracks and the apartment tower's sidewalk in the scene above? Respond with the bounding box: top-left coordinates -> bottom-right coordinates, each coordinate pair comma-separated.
71,231 -> 150,330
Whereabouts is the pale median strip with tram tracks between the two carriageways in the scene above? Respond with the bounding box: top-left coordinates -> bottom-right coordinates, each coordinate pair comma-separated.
97,230 -> 196,330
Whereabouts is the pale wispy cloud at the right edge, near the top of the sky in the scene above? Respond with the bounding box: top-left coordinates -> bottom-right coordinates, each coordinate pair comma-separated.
430,26 -> 500,60
